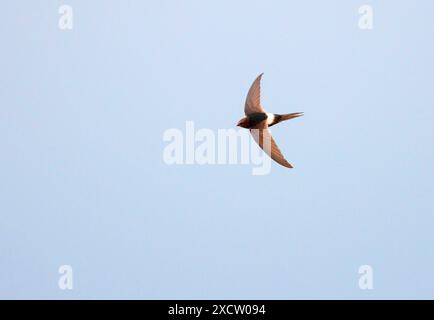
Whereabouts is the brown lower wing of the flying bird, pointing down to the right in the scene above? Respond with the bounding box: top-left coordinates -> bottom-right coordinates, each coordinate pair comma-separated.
250,120 -> 293,168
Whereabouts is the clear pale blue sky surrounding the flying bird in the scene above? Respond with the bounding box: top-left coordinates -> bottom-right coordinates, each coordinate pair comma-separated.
0,0 -> 434,299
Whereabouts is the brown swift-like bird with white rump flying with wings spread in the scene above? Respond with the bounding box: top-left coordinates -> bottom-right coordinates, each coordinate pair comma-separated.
237,73 -> 303,168
